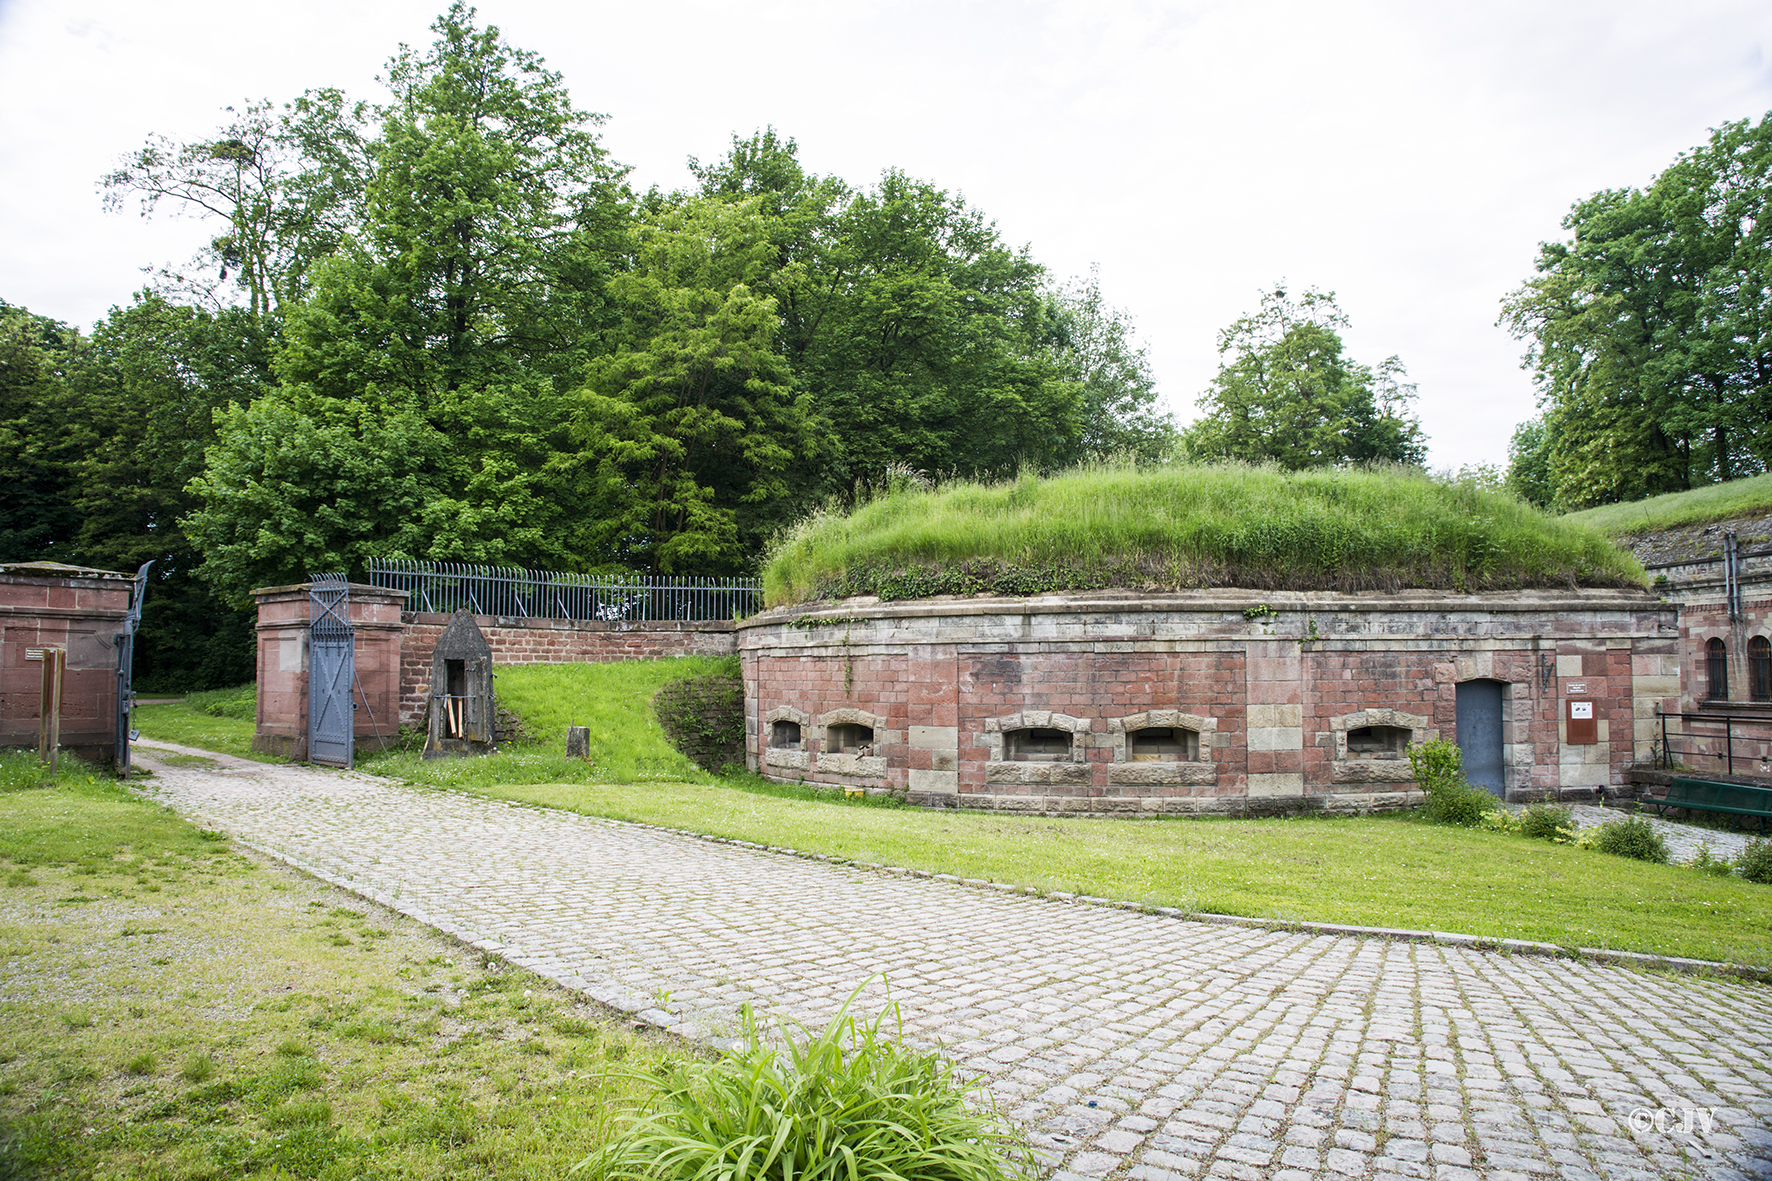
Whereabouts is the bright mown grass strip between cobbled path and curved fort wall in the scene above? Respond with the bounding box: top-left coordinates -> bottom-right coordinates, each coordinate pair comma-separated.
435,784 -> 1772,966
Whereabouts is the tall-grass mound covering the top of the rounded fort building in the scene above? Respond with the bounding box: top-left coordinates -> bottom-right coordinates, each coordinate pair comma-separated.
764,465 -> 1644,606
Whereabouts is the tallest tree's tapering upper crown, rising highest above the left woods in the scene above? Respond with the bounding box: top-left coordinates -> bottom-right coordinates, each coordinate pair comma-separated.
278,4 -> 629,406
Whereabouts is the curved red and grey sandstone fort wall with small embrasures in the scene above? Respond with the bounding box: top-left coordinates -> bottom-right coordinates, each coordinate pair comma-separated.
739,591 -> 1680,814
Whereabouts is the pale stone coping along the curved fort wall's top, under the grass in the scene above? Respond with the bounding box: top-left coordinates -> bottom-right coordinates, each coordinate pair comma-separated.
737,589 -> 1675,631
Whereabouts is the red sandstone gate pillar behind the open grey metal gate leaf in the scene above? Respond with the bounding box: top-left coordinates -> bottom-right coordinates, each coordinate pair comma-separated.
252,582 -> 406,761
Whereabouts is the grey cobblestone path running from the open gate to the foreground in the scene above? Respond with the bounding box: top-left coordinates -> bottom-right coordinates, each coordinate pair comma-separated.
138,748 -> 1772,1181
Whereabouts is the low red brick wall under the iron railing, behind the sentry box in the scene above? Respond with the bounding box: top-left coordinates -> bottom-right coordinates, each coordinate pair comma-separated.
400,612 -> 735,725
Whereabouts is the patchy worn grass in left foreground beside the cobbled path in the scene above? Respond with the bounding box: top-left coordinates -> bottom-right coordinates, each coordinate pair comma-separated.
0,755 -> 684,1179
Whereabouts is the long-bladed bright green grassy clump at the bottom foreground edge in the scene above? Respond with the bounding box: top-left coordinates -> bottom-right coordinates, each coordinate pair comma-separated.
588,993 -> 1030,1181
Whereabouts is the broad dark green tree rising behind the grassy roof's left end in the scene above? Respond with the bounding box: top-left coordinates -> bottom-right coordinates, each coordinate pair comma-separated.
696,129 -> 1084,502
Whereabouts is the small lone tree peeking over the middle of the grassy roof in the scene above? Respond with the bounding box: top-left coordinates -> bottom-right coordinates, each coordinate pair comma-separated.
1184,287 -> 1426,470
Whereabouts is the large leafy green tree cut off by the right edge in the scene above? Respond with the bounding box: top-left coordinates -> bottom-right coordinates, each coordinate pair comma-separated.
1501,115 -> 1772,509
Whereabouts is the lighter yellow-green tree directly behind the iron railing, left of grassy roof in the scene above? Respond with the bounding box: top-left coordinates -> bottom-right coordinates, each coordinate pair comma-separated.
576,199 -> 813,573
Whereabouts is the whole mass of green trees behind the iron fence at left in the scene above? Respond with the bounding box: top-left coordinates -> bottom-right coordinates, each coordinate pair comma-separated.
10,4 -> 1175,688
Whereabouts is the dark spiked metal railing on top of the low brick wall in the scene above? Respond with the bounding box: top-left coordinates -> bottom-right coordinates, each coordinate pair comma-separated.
369,559 -> 764,622
